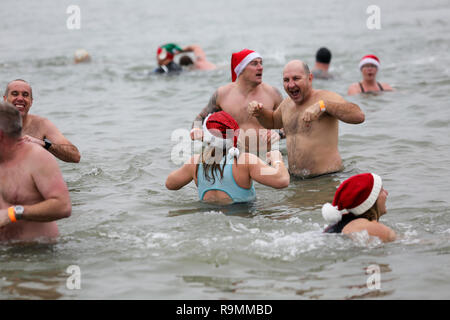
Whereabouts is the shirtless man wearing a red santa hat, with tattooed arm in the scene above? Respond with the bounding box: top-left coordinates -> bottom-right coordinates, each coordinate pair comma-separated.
191,49 -> 283,155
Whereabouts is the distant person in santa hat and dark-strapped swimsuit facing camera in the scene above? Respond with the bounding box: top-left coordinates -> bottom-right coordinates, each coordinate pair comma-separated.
348,54 -> 394,95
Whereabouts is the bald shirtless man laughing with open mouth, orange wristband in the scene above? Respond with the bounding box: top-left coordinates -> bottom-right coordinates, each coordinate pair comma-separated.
248,60 -> 364,178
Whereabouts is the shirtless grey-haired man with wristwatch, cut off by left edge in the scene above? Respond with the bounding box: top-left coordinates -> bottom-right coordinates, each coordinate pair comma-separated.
0,101 -> 72,242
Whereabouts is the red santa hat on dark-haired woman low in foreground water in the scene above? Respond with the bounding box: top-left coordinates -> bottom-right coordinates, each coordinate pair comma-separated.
322,173 -> 382,223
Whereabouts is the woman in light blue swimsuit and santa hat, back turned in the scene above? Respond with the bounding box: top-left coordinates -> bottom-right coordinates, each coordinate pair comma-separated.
166,111 -> 290,204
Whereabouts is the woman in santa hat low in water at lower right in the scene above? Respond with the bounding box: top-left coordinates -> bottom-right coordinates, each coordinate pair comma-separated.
322,173 -> 396,242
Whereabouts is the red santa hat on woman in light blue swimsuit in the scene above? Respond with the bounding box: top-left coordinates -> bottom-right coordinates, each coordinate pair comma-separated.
203,111 -> 239,157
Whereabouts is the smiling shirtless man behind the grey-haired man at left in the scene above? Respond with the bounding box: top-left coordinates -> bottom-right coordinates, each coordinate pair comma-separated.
3,79 -> 81,163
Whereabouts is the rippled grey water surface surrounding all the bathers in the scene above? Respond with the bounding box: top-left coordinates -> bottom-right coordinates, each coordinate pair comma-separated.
0,0 -> 450,299
